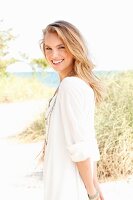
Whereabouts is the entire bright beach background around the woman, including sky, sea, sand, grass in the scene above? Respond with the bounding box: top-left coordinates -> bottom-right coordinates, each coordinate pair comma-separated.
0,0 -> 133,200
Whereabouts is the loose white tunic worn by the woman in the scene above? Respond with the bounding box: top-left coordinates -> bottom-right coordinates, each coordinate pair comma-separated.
44,77 -> 99,200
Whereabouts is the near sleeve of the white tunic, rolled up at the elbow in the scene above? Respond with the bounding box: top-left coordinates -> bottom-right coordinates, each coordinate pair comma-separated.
59,79 -> 100,162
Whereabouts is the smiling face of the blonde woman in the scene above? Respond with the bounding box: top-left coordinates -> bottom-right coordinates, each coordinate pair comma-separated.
44,32 -> 74,77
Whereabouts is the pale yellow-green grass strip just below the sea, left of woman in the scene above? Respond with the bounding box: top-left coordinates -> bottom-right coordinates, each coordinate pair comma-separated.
0,75 -> 54,103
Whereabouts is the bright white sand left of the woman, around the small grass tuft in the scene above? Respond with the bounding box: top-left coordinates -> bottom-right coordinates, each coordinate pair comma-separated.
0,100 -> 47,200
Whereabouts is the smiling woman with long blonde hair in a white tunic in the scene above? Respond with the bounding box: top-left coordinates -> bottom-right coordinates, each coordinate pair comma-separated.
41,21 -> 103,200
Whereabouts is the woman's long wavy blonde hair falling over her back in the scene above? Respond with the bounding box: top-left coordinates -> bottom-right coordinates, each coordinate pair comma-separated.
40,20 -> 104,103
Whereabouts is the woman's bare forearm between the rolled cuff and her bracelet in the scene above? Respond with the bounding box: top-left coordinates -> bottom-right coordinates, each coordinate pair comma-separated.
76,159 -> 97,196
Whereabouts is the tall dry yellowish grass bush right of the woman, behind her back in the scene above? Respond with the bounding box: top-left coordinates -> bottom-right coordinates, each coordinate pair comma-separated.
95,72 -> 133,181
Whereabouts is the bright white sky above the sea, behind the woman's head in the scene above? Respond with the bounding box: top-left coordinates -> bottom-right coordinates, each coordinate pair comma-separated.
0,0 -> 133,70
